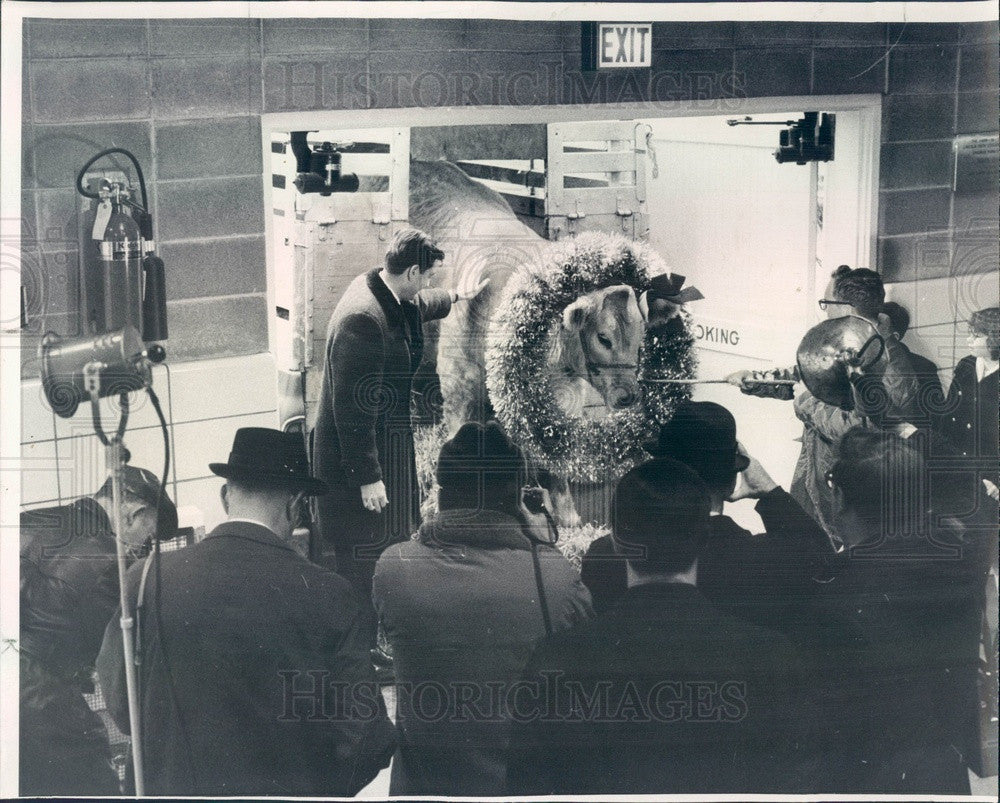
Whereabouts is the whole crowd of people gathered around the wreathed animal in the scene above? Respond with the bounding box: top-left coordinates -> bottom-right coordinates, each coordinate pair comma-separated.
21,230 -> 1000,797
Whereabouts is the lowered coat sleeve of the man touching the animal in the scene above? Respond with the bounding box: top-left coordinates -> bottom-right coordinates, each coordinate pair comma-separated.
326,313 -> 391,486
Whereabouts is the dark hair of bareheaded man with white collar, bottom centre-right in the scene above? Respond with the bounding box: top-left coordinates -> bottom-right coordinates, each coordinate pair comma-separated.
612,457 -> 711,574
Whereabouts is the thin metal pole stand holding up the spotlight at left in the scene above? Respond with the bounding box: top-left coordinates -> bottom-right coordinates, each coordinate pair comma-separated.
83,362 -> 145,797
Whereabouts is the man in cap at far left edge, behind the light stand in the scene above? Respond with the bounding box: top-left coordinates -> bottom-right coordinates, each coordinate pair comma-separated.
19,466 -> 177,796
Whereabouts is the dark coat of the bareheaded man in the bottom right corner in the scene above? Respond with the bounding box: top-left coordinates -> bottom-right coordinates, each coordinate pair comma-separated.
793,525 -> 996,795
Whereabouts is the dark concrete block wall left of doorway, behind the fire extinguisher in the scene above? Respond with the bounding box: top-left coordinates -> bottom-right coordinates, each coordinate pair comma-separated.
22,19 -> 267,376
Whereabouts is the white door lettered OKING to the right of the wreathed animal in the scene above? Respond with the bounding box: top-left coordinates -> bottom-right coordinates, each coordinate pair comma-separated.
642,108 -> 878,531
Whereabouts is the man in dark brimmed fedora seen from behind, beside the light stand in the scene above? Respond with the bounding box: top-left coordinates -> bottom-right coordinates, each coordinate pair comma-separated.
98,428 -> 394,797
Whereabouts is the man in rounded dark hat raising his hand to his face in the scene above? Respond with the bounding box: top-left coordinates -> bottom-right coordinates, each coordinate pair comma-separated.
582,402 -> 835,630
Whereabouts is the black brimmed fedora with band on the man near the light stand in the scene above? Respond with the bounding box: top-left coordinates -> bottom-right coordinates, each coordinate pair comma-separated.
208,427 -> 329,496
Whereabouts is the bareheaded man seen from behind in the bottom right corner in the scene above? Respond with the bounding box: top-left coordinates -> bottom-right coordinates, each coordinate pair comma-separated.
808,428 -> 996,795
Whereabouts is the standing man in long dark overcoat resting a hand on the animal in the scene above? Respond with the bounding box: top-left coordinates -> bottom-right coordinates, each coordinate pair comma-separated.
313,229 -> 482,637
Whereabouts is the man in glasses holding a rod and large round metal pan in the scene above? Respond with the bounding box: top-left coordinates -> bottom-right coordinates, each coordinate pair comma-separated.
727,265 -> 922,538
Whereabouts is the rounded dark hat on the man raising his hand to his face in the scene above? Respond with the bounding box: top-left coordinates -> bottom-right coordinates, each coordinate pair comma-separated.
651,401 -> 750,486
